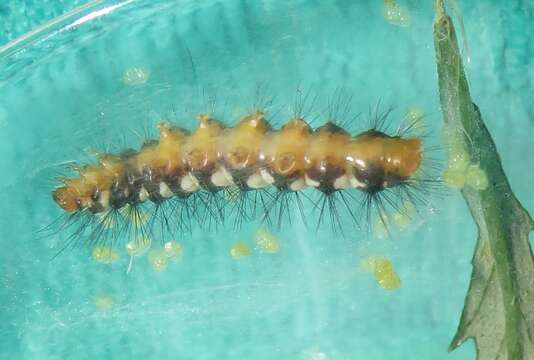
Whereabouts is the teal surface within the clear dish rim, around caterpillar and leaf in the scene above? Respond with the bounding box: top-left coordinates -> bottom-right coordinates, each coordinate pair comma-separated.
0,0 -> 534,360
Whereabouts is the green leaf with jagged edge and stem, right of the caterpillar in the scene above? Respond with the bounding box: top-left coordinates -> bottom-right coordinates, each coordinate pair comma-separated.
434,0 -> 534,360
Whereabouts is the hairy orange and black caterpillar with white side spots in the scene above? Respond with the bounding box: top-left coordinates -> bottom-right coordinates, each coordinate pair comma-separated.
48,98 -> 436,253
